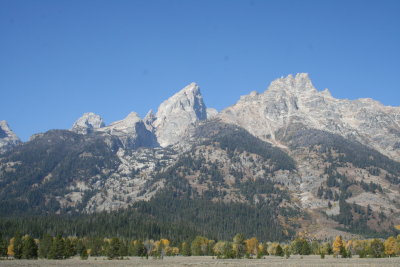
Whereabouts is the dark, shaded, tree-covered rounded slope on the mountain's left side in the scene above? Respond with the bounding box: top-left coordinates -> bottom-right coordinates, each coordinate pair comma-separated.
0,130 -> 119,214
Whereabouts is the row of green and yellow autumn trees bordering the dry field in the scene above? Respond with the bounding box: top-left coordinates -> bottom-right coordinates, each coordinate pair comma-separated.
0,233 -> 400,260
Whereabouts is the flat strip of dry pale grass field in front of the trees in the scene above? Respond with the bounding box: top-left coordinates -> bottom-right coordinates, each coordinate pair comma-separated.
0,256 -> 400,267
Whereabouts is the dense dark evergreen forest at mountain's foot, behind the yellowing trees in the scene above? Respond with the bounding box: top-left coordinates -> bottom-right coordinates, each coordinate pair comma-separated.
0,191 -> 291,242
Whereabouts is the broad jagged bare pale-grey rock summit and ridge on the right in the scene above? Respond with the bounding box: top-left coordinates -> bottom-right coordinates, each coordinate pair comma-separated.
219,73 -> 400,160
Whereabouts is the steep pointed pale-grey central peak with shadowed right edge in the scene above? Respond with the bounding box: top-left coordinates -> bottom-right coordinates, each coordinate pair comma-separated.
152,83 -> 207,146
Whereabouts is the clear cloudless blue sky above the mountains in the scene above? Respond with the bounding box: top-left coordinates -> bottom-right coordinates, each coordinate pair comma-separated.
0,0 -> 400,140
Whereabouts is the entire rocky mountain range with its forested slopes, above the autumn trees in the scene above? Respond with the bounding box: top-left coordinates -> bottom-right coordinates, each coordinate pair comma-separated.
0,74 -> 400,241
